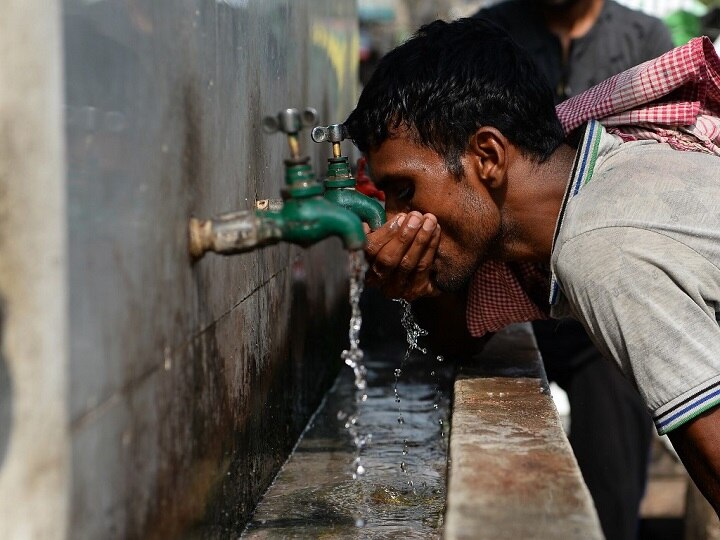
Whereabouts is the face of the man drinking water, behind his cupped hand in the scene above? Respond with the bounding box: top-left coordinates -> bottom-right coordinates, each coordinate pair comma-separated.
368,133 -> 500,291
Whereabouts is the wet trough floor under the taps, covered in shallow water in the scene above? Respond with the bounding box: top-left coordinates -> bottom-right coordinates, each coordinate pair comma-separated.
242,342 -> 454,539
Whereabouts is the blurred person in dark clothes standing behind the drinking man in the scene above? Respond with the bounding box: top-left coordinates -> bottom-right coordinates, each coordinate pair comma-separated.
475,0 -> 673,540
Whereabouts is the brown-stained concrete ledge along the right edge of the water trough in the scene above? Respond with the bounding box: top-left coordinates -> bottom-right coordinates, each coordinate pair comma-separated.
444,324 -> 603,540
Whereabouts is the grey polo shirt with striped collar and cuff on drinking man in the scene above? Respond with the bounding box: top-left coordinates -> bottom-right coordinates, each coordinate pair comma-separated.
551,122 -> 720,433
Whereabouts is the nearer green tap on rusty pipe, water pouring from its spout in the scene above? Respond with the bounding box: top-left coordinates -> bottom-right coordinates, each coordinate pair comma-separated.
189,109 -> 365,259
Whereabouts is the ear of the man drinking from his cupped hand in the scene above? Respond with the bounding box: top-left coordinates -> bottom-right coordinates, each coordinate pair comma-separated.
467,126 -> 510,189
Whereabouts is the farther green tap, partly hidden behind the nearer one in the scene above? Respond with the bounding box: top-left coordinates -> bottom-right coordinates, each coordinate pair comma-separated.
311,124 -> 385,230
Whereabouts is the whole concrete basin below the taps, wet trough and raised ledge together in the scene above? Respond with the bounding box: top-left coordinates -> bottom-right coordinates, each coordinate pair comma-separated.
243,325 -> 603,540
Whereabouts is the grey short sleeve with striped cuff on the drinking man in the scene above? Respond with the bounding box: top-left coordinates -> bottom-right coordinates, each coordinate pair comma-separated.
555,227 -> 720,433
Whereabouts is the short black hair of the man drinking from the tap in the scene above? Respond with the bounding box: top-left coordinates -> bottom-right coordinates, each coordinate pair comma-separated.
345,18 -> 564,177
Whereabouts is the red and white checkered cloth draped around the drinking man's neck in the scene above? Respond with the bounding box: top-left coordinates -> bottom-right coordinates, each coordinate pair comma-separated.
466,37 -> 720,336
